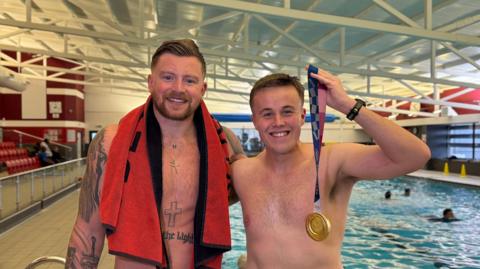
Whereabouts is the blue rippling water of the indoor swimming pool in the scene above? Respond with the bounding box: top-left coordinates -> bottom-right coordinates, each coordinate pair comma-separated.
223,177 -> 480,269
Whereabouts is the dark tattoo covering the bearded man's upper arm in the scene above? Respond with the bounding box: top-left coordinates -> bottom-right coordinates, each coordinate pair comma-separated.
79,130 -> 107,222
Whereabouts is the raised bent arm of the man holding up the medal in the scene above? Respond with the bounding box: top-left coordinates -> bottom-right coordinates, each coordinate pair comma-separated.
312,69 -> 430,179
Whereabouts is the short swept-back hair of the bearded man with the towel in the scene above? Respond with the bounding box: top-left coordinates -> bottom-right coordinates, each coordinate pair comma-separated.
150,39 -> 207,76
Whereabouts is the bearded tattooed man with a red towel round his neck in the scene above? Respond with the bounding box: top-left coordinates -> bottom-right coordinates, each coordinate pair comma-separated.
66,40 -> 242,269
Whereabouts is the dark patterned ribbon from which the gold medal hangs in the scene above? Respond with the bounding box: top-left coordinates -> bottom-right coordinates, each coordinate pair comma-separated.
308,65 -> 327,211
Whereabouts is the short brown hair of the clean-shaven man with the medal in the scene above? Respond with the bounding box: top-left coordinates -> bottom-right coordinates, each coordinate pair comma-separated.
250,73 -> 305,111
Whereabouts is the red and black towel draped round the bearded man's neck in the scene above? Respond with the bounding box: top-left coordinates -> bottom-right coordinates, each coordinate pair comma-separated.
100,98 -> 231,268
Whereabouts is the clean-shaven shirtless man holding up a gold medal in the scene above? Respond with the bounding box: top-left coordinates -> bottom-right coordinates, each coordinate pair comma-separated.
232,70 -> 430,269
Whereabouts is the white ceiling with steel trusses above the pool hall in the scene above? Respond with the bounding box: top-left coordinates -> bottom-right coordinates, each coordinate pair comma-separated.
0,0 -> 480,116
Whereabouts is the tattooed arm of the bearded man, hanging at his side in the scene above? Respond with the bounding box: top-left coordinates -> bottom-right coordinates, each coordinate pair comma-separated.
65,127 -> 110,269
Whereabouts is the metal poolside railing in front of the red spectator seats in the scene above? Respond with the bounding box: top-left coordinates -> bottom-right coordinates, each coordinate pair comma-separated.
0,158 -> 86,221
